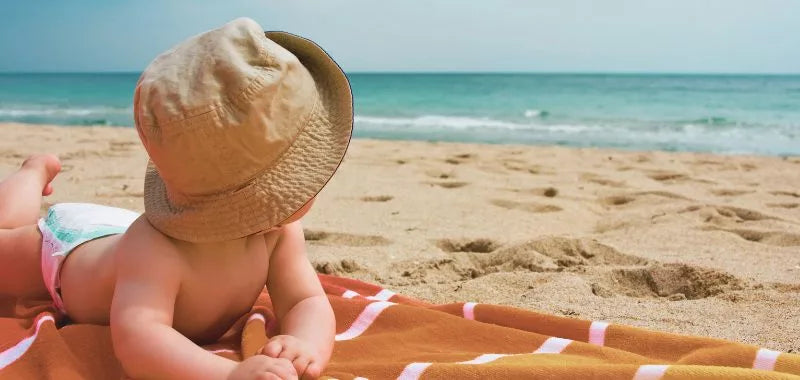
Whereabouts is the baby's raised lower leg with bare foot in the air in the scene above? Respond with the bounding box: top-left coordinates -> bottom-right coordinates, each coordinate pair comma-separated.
0,154 -> 61,229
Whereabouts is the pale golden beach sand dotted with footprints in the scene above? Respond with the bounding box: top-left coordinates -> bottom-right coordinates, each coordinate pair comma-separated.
0,124 -> 800,352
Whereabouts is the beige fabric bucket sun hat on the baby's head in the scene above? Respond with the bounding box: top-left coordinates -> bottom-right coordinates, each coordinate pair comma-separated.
133,18 -> 353,242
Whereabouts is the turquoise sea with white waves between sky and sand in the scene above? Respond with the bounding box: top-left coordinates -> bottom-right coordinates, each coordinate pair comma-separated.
0,74 -> 800,155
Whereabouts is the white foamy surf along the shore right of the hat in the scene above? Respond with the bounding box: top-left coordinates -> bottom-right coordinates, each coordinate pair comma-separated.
355,115 -> 800,155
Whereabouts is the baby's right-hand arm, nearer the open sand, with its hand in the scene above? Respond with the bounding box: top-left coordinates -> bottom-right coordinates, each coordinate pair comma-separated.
264,222 -> 336,378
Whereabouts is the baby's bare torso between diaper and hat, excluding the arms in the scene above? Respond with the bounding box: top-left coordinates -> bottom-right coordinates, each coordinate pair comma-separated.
61,217 -> 277,342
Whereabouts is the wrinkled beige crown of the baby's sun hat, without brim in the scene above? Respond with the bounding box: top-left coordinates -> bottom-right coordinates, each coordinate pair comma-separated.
134,18 -> 318,197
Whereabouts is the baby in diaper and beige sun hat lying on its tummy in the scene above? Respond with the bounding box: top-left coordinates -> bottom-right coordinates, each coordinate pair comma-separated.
0,19 -> 353,379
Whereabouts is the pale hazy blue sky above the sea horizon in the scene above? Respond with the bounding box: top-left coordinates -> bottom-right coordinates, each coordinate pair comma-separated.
0,0 -> 800,74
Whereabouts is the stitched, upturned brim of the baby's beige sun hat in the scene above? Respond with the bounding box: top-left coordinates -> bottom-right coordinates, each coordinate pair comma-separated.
144,32 -> 353,243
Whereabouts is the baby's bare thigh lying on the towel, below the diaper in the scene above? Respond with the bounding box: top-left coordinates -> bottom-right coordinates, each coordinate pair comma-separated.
0,224 -> 49,298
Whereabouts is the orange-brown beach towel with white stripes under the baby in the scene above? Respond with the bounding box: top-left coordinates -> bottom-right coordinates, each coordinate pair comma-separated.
0,275 -> 800,380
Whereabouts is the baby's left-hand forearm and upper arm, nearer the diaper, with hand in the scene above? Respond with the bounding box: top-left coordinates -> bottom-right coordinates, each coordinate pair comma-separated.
111,218 -> 295,379
